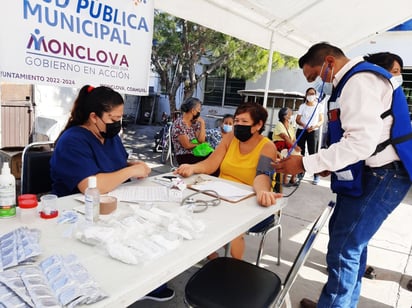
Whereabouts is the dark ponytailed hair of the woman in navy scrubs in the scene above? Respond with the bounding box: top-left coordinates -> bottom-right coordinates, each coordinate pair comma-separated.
62,85 -> 124,133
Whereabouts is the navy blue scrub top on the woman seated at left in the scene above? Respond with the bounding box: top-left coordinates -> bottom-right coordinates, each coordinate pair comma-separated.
50,126 -> 127,197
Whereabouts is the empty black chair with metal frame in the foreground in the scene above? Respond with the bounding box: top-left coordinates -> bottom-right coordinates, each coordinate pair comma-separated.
185,201 -> 335,308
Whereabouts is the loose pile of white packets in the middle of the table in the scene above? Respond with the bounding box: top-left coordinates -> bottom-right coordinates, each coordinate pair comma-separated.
76,204 -> 205,264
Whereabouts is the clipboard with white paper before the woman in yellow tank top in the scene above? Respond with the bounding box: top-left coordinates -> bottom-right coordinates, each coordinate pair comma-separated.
187,180 -> 255,203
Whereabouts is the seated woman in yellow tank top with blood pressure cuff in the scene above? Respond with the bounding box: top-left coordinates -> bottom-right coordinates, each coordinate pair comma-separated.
175,103 -> 282,259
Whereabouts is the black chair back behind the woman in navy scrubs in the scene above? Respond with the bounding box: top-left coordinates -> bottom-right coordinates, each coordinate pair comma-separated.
21,141 -> 54,195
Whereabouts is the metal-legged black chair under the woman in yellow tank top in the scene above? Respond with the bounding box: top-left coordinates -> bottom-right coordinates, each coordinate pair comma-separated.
246,173 -> 282,266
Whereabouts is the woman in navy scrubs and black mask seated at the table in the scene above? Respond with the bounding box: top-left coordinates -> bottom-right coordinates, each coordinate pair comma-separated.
50,85 -> 150,197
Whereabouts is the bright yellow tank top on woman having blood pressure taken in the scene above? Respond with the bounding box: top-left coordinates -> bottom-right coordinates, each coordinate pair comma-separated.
219,137 -> 271,185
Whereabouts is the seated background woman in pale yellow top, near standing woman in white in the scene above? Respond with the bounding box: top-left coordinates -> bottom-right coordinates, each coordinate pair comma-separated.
272,107 -> 300,186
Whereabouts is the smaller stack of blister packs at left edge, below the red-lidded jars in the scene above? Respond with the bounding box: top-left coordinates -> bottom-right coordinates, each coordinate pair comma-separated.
0,227 -> 41,271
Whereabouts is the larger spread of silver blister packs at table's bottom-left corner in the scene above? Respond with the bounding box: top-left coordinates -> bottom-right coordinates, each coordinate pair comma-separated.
0,255 -> 107,308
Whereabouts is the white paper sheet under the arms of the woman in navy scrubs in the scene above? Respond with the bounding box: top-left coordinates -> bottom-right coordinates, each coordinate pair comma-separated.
109,185 -> 169,202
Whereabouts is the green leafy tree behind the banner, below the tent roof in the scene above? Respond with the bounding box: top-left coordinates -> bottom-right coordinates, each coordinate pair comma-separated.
151,11 -> 297,112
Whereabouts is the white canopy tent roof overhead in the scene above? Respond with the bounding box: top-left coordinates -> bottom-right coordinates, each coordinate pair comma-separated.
155,0 -> 412,57
